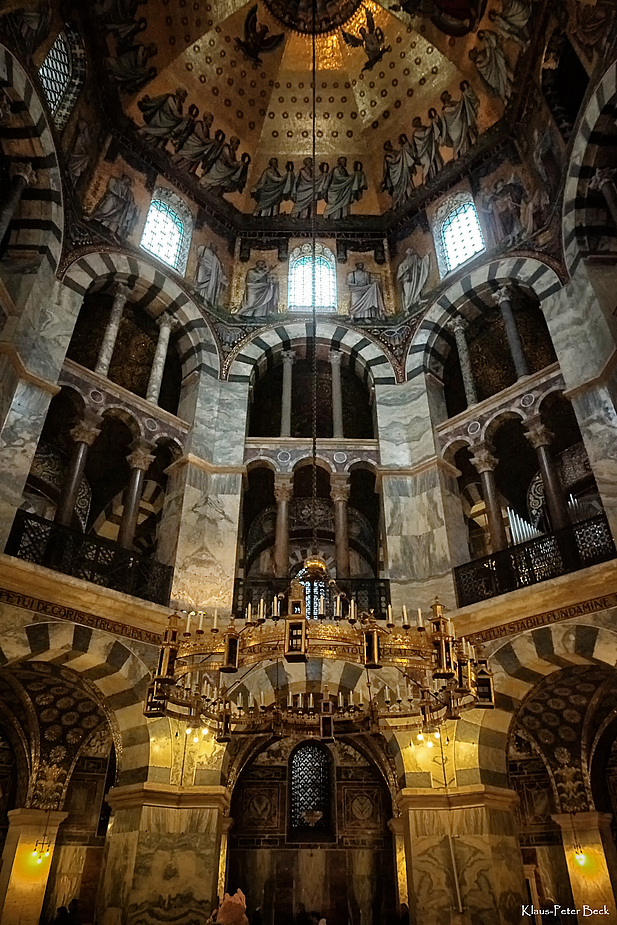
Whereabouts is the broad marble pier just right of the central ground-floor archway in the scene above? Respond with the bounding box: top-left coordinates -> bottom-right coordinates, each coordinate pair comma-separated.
398,784 -> 528,925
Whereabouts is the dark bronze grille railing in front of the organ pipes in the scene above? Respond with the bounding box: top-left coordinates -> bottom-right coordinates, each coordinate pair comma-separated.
454,514 -> 617,607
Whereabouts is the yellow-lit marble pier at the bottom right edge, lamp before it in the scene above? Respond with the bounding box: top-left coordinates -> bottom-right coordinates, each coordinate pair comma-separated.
552,812 -> 617,925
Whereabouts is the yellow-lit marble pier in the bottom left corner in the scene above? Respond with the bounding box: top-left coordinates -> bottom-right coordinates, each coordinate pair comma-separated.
0,809 -> 68,925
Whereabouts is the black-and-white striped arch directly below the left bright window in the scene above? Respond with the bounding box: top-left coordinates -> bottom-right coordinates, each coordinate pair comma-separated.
62,251 -> 219,379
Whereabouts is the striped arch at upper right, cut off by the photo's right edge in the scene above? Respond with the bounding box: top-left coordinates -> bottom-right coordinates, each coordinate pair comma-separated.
562,62 -> 617,274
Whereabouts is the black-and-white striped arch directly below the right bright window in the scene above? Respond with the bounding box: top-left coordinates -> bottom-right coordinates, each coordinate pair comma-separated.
406,257 -> 563,379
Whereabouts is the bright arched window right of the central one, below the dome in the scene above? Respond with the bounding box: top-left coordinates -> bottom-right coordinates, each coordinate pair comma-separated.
433,192 -> 485,276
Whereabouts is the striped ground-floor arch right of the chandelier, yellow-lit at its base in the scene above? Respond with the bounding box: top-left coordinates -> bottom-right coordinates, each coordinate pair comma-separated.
455,623 -> 617,787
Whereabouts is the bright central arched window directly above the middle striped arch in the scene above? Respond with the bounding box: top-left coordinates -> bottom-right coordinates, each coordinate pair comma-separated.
289,243 -> 336,312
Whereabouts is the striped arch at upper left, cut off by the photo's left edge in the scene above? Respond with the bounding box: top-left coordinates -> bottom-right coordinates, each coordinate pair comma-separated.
0,45 -> 64,273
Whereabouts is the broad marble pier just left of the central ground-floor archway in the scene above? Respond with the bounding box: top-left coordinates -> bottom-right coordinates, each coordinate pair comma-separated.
95,783 -> 229,925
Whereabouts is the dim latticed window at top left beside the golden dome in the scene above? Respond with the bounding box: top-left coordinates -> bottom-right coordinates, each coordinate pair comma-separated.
39,24 -> 86,131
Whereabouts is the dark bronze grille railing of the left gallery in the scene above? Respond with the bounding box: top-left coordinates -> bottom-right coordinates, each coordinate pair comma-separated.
5,510 -> 173,606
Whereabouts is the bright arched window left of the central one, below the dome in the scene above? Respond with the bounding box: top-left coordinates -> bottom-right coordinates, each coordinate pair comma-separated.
141,189 -> 192,273
